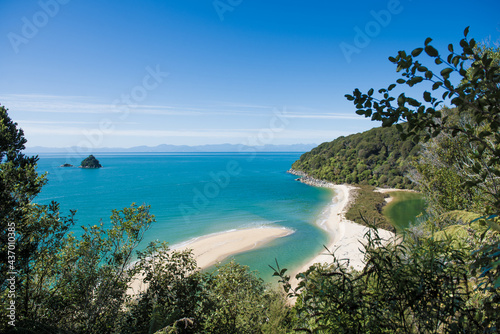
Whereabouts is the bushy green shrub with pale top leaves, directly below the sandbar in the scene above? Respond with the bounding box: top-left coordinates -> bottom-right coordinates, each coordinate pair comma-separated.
119,242 -> 202,333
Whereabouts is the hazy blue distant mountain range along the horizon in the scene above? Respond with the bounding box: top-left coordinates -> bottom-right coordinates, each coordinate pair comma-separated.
25,144 -> 317,154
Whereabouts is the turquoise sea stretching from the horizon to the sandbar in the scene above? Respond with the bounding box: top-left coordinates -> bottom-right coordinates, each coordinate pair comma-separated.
36,153 -> 332,282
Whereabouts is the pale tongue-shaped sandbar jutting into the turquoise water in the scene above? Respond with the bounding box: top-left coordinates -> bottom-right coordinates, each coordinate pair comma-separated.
128,227 -> 293,295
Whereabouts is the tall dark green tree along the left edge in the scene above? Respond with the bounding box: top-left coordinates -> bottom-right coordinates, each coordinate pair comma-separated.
0,106 -> 68,330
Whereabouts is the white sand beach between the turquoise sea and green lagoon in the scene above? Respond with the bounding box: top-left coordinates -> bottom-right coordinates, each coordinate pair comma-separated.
288,170 -> 394,288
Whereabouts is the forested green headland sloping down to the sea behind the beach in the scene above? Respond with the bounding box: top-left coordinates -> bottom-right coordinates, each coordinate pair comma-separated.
292,127 -> 420,189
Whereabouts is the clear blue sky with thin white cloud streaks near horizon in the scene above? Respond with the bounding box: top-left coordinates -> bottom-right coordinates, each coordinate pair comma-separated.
0,0 -> 500,147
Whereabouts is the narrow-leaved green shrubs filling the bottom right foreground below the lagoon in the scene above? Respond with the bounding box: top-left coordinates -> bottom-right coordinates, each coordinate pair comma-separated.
276,228 -> 499,333
